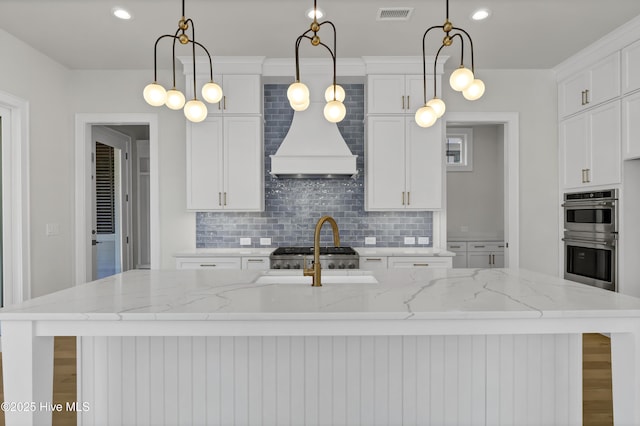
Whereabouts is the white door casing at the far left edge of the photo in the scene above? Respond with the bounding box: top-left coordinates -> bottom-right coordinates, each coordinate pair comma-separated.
0,91 -> 31,306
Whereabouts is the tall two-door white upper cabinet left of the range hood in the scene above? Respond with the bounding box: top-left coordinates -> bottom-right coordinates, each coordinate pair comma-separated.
187,116 -> 264,211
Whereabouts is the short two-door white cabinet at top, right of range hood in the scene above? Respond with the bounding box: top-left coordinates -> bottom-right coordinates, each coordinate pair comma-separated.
367,74 -> 433,114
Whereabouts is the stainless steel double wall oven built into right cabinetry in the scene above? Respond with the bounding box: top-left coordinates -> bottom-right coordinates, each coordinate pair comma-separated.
562,189 -> 618,291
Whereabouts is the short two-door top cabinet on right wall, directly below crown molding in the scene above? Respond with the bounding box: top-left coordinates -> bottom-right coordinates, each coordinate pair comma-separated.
558,52 -> 620,118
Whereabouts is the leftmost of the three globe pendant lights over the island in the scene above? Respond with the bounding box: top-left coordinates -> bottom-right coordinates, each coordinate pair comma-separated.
143,0 -> 222,123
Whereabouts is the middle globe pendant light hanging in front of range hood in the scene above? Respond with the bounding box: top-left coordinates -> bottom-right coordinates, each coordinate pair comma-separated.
287,0 -> 347,123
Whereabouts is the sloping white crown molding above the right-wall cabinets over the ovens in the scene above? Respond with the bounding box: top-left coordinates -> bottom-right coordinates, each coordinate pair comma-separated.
553,16 -> 640,81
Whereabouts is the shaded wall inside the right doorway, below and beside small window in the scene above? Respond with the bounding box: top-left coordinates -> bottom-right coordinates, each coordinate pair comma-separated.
447,124 -> 504,240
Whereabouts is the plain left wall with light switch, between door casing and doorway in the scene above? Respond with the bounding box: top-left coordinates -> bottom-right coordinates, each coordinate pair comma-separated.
0,30 -> 74,296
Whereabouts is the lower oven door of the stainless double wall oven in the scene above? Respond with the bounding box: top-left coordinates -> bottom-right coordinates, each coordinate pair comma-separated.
563,234 -> 617,291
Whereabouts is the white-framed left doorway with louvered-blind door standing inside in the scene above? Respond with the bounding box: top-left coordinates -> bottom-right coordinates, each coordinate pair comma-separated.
75,114 -> 160,284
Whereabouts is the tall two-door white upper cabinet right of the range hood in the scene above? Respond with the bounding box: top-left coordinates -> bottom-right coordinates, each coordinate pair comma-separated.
365,116 -> 443,211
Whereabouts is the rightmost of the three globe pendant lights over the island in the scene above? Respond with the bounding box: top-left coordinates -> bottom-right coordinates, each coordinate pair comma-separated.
415,0 -> 484,127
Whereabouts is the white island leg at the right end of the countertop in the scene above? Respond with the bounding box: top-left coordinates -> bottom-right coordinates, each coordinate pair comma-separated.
611,319 -> 640,425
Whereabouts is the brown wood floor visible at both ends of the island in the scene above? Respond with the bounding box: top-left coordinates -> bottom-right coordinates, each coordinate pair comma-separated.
0,334 -> 613,426
